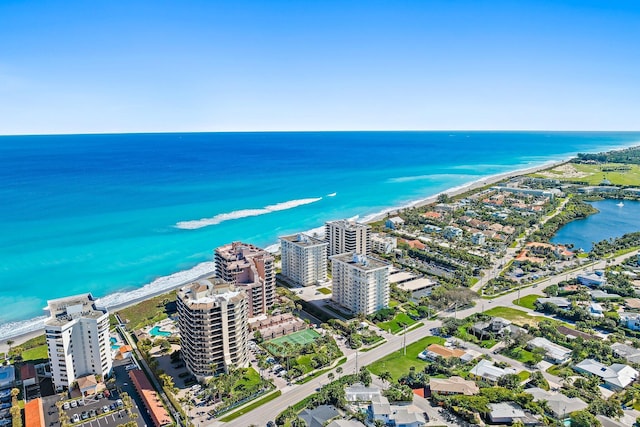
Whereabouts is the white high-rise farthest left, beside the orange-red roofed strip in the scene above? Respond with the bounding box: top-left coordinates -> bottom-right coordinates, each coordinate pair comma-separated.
44,294 -> 112,391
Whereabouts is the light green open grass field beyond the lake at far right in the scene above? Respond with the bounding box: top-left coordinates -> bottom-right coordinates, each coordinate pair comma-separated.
536,163 -> 640,186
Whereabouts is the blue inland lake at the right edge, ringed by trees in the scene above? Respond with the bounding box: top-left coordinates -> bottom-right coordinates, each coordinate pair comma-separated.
551,199 -> 640,252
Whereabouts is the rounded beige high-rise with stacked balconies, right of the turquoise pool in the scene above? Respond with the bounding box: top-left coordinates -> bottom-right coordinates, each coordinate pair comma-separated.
177,278 -> 249,379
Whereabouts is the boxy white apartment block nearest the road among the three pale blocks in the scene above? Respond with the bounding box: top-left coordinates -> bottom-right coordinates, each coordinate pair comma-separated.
329,252 -> 390,314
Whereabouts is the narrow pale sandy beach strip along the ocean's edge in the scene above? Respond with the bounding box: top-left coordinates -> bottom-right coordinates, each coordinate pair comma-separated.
0,159 -> 568,353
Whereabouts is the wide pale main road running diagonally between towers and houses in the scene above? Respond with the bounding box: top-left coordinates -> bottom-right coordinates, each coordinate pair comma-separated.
218,251 -> 639,427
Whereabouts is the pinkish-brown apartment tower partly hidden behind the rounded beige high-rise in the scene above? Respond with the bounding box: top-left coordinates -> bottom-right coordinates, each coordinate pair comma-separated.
215,242 -> 276,317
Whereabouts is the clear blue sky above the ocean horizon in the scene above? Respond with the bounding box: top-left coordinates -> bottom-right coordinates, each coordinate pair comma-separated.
0,0 -> 640,134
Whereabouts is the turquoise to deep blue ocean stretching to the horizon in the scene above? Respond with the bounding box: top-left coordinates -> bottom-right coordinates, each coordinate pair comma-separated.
0,132 -> 640,339
